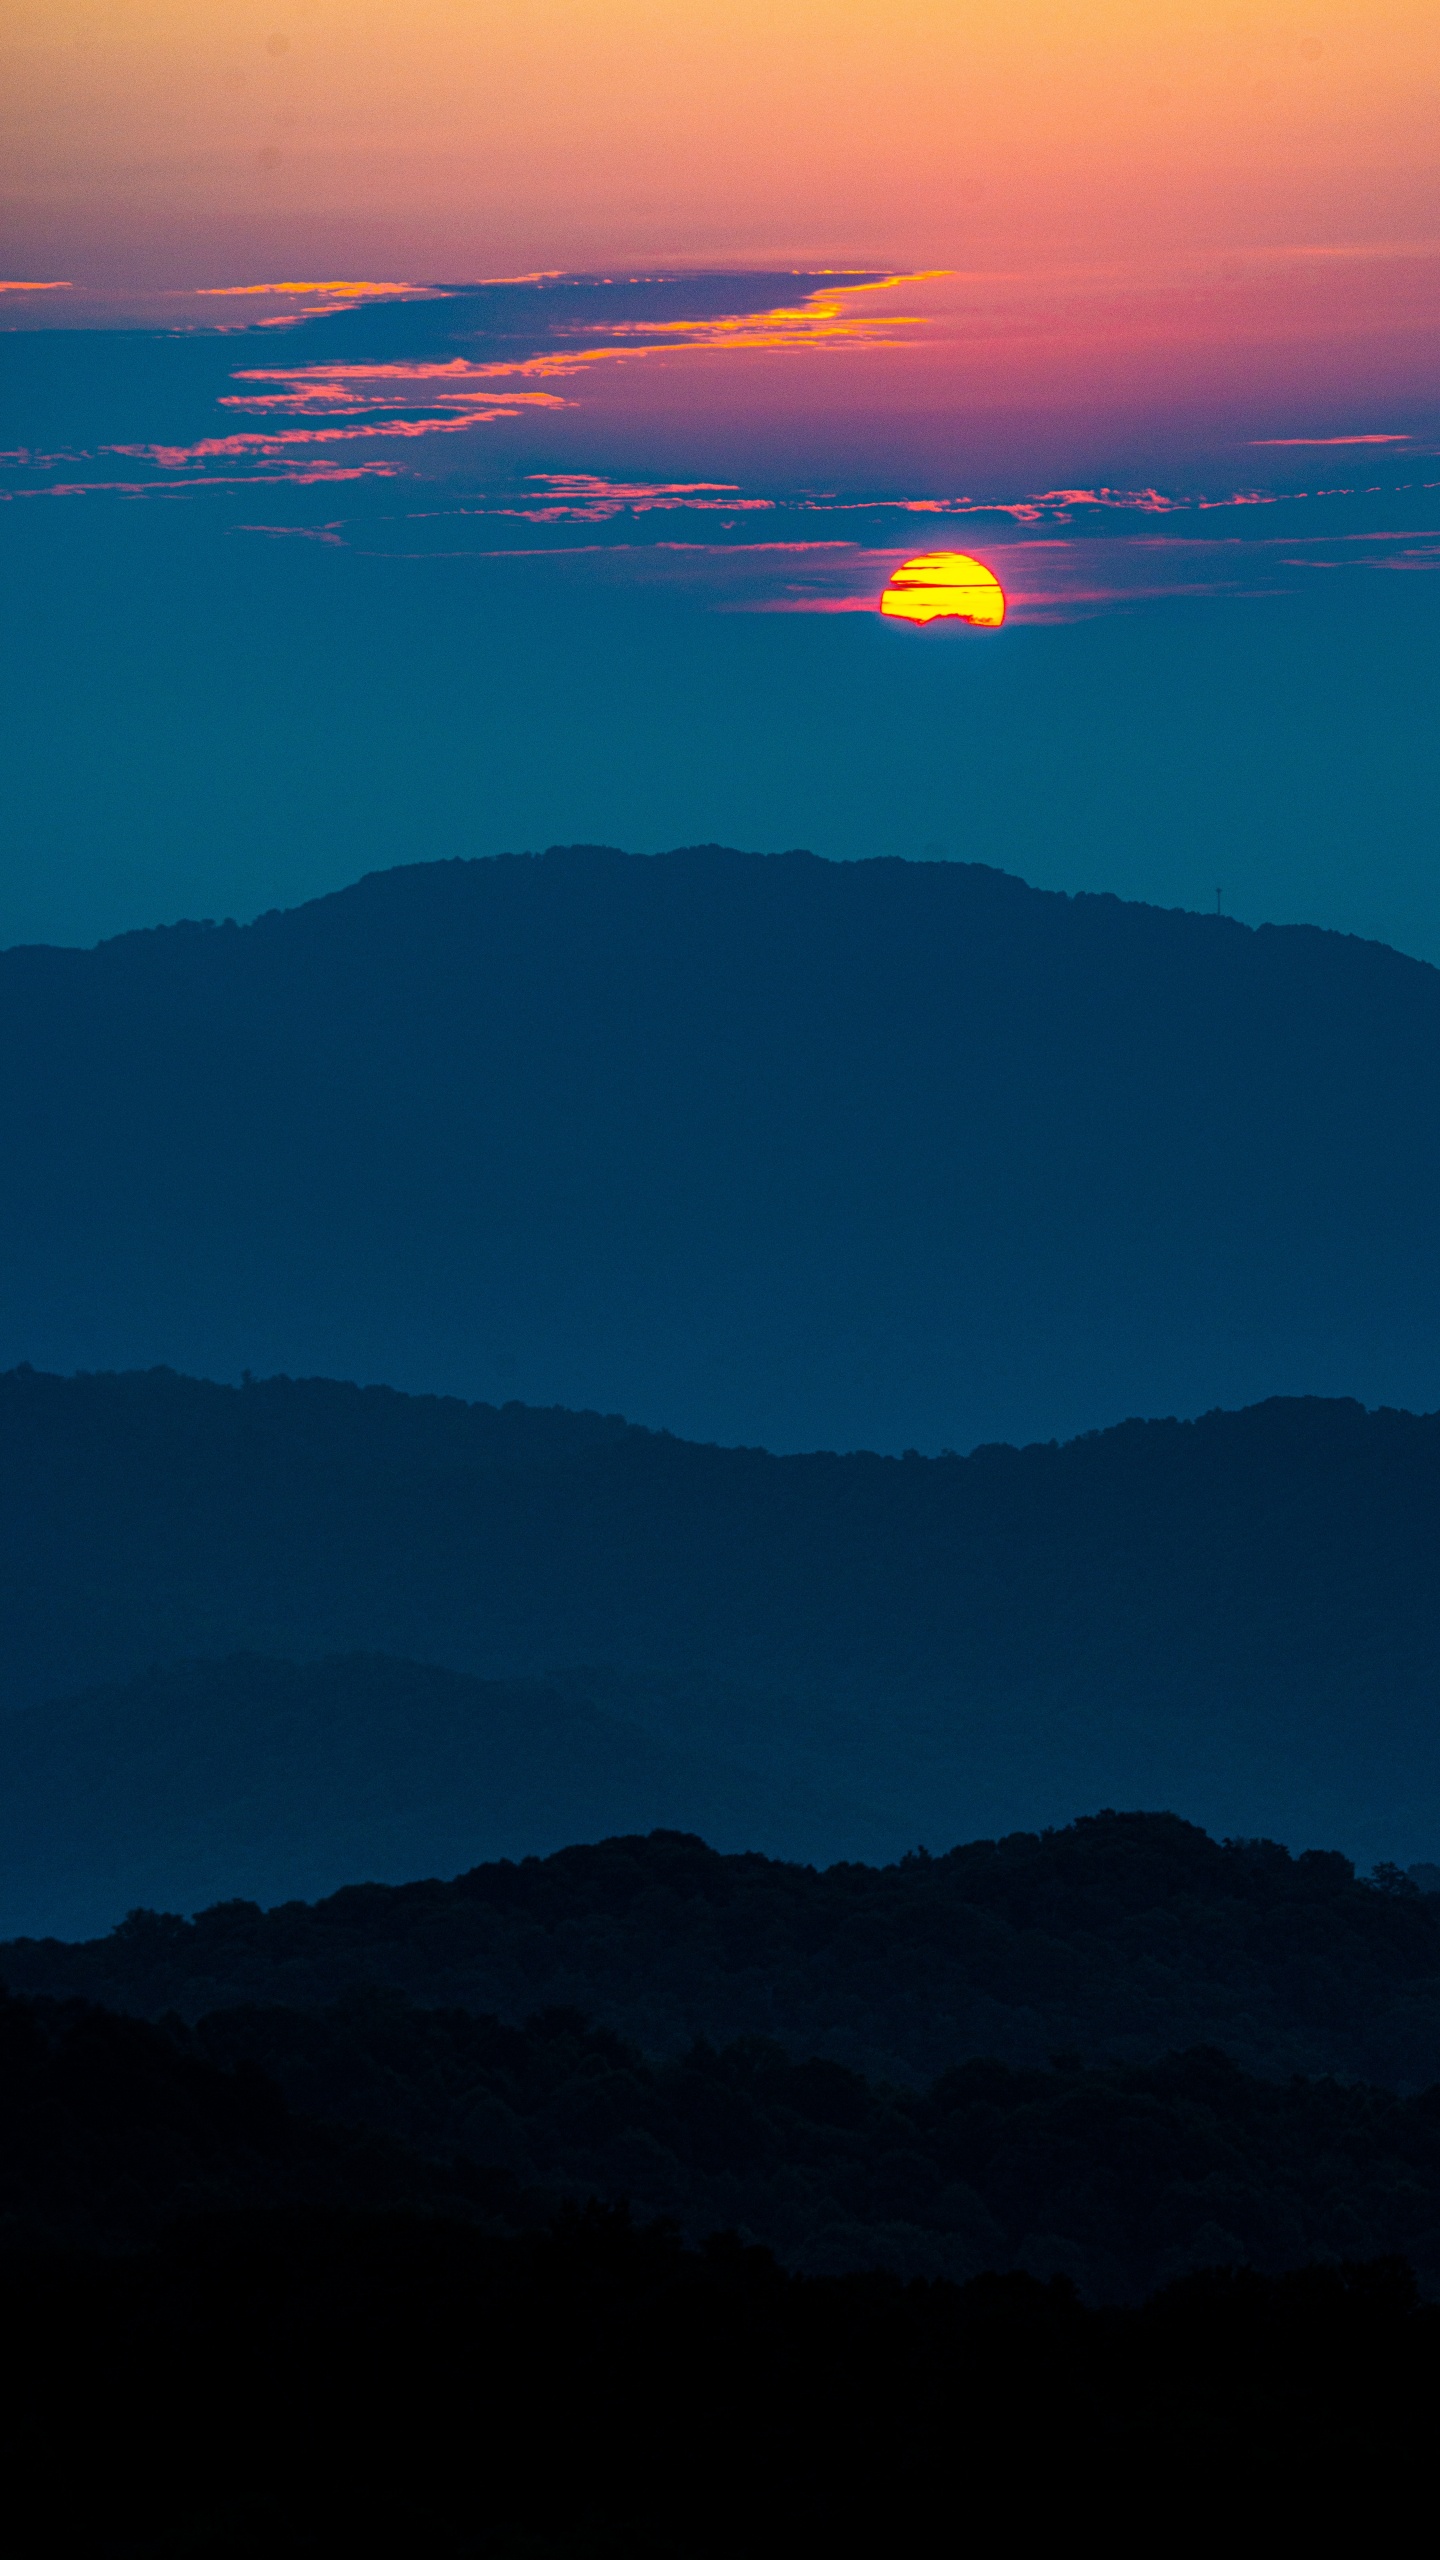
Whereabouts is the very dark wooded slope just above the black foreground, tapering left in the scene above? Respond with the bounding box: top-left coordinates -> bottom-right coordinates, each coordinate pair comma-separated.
195,1994 -> 1440,2301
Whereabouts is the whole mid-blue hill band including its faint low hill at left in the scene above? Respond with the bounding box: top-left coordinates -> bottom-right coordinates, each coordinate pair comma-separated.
0,1370 -> 1440,1930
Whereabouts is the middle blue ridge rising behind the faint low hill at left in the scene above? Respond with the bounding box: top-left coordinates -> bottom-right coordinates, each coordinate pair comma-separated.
0,1372 -> 1440,1873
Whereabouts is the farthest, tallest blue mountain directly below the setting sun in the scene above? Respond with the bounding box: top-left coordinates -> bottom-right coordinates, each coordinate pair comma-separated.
0,847 -> 1440,1449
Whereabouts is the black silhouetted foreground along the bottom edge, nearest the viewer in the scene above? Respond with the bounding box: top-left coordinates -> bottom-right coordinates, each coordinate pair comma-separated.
0,2212 -> 1440,2560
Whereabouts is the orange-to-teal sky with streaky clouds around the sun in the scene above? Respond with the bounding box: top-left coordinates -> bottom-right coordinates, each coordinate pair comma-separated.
0,0 -> 1440,963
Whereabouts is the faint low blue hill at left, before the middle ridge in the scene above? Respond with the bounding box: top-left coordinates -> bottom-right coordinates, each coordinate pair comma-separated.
0,1654 -> 843,1938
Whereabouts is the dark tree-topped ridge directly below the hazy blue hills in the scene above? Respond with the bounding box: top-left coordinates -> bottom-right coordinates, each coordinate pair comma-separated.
11,1815 -> 1440,2089
